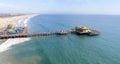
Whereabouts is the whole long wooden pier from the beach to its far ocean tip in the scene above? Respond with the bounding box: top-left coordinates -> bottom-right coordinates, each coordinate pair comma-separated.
0,27 -> 99,39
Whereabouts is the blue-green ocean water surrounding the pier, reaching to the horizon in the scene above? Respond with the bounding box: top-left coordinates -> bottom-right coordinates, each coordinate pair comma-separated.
0,14 -> 120,64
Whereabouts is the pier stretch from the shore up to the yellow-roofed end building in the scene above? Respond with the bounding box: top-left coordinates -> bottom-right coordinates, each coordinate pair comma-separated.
0,28 -> 74,39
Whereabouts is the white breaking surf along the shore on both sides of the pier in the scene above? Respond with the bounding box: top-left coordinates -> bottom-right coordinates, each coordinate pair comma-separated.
0,16 -> 37,52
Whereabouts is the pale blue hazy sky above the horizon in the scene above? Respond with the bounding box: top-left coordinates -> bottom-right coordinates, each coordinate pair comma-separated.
0,0 -> 120,14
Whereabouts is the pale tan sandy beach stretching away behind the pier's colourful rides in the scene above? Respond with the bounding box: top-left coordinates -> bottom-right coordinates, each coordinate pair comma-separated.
0,14 -> 33,28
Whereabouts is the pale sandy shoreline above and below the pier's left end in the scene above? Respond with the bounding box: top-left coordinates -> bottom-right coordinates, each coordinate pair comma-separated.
0,14 -> 36,44
